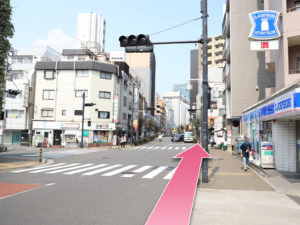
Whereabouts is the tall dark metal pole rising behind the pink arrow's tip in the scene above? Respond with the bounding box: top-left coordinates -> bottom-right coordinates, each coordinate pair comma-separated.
201,0 -> 208,183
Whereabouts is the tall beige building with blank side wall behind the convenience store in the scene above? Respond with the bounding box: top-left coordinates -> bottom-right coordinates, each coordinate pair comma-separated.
222,0 -> 275,148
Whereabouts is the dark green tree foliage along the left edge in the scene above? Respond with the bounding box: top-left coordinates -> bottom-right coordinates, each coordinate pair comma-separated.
0,0 -> 14,111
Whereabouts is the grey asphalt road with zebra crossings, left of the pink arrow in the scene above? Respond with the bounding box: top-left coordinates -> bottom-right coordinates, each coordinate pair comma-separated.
0,138 -> 192,225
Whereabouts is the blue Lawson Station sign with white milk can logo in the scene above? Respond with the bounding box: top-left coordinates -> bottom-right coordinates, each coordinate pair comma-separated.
249,10 -> 280,40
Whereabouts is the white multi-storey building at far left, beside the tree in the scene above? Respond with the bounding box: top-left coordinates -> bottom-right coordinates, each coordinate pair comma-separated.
1,46 -> 61,145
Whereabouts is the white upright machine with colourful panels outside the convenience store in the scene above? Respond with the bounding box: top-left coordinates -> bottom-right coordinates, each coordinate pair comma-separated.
260,141 -> 275,168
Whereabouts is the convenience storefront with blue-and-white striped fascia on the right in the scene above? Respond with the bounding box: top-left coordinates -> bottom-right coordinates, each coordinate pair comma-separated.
243,83 -> 300,172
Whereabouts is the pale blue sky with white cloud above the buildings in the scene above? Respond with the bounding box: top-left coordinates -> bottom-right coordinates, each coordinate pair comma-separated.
11,0 -> 224,96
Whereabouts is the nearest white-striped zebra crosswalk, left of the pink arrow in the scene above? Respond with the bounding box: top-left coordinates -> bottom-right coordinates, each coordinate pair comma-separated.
11,163 -> 176,180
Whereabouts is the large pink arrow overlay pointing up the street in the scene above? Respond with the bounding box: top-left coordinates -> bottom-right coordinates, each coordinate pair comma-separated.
145,144 -> 211,225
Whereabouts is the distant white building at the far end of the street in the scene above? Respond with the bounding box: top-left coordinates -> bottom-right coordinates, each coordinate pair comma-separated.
162,91 -> 190,129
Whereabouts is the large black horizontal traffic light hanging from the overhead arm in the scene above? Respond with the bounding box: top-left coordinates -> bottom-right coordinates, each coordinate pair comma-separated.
119,34 -> 153,52
